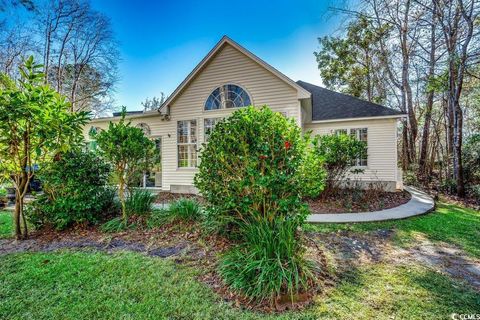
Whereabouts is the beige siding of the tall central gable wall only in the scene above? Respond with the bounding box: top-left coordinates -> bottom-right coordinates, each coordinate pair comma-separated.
163,44 -> 301,190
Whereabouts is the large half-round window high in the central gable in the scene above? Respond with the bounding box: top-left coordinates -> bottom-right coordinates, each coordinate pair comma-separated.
205,84 -> 252,110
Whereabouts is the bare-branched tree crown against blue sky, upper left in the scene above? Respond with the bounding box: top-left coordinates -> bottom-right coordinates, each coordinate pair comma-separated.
0,0 -> 119,116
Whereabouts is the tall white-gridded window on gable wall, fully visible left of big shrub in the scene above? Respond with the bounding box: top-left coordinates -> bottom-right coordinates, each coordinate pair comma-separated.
177,120 -> 197,168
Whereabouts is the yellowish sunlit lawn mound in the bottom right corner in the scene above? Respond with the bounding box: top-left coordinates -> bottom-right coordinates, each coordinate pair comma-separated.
313,264 -> 480,319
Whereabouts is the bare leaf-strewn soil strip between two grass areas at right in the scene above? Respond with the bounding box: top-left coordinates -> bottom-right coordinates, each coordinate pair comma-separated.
308,229 -> 480,292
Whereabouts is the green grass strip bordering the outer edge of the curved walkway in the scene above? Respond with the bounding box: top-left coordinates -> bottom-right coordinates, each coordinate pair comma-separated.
305,203 -> 480,258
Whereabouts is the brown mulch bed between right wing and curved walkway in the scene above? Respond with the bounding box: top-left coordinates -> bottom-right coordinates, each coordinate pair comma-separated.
307,189 -> 411,214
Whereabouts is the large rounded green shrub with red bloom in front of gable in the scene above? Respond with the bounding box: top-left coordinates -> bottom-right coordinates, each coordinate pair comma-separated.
195,106 -> 324,234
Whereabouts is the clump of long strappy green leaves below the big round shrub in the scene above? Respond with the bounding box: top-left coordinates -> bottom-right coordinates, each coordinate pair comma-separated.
219,219 -> 315,302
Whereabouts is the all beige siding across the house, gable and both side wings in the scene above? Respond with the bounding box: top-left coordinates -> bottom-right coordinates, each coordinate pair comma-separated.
84,44 -> 401,190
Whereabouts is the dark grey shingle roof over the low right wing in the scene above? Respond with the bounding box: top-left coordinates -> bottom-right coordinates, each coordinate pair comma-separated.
297,81 -> 404,121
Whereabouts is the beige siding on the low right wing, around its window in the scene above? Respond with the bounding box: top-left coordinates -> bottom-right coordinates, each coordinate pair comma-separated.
304,119 -> 398,181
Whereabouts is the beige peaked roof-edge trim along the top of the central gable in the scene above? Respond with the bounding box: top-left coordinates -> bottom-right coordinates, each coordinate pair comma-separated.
158,36 -> 310,112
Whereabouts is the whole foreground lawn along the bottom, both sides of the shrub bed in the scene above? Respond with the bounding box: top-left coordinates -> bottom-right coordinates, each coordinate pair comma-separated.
0,251 -> 480,319
